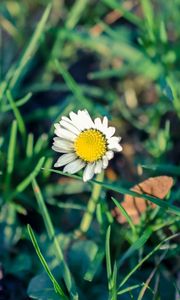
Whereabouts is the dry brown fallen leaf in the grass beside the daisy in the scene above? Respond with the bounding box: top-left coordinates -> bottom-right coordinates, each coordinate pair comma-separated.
112,176 -> 173,224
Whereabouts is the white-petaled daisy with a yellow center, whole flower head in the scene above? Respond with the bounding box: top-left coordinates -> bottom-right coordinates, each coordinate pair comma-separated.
52,110 -> 122,181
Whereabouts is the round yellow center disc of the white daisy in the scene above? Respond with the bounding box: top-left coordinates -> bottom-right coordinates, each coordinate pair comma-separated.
74,129 -> 107,162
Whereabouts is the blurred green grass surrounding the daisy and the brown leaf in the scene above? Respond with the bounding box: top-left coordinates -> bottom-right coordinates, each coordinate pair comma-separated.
0,0 -> 180,300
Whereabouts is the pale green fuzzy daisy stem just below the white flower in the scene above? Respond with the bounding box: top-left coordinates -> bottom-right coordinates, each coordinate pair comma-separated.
79,172 -> 104,234
